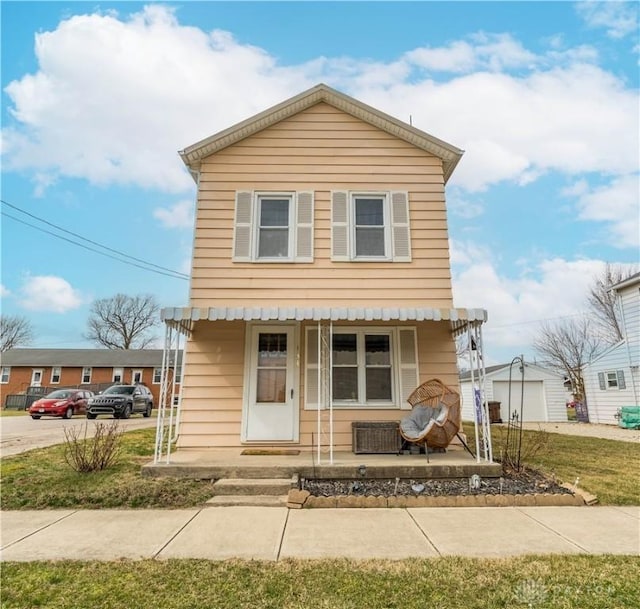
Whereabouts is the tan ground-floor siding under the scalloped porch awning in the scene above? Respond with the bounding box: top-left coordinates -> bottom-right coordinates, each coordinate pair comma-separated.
178,321 -> 458,450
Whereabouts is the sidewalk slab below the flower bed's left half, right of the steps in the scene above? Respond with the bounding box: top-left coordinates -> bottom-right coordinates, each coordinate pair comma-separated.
280,508 -> 438,559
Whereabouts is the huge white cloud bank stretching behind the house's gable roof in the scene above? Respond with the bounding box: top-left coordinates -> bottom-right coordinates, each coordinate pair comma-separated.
2,5 -> 640,252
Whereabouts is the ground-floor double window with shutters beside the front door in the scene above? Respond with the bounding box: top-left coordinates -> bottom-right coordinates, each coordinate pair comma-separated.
305,326 -> 419,410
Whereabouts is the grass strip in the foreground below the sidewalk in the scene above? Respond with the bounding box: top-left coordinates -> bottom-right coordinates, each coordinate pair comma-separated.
0,555 -> 640,609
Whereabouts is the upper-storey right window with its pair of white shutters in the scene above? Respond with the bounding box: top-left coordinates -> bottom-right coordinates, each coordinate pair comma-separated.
331,191 -> 411,262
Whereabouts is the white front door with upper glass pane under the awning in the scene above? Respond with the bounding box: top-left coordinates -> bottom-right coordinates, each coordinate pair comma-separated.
242,326 -> 298,442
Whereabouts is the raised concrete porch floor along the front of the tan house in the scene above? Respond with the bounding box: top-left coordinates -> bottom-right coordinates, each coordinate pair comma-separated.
142,446 -> 502,479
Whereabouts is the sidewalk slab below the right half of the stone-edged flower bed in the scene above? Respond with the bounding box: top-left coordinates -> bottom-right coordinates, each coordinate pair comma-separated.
408,507 -> 586,557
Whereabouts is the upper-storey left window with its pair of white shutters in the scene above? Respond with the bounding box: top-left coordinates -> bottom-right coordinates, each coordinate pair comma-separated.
233,191 -> 313,262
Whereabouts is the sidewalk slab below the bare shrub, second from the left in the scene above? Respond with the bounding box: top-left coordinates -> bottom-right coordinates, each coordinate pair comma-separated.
2,510 -> 198,561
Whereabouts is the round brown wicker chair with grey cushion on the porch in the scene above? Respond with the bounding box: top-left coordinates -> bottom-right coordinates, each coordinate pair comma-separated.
400,379 -> 460,455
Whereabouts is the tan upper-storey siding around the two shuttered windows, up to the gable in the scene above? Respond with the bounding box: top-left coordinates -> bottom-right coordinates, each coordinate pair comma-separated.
190,103 -> 452,307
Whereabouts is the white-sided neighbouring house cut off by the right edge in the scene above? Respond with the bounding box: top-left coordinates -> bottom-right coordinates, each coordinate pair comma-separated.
583,273 -> 640,424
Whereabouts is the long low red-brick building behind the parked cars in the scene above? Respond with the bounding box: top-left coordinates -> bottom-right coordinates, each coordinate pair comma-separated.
0,349 -> 181,405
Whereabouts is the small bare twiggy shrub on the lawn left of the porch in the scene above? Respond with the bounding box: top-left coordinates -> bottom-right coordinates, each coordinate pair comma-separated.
64,421 -> 123,473
